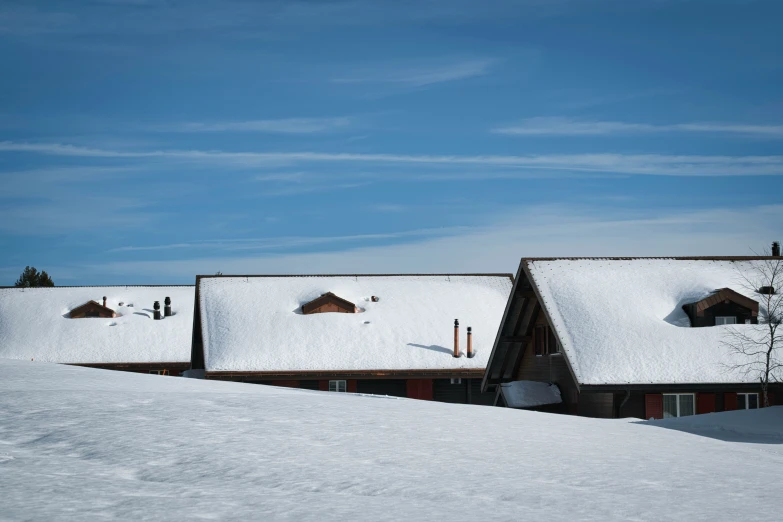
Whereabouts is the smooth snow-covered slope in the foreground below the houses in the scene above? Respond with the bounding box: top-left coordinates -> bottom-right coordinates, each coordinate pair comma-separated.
0,359 -> 783,522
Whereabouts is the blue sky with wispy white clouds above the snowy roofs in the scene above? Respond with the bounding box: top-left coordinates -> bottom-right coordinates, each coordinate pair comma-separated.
0,0 -> 783,284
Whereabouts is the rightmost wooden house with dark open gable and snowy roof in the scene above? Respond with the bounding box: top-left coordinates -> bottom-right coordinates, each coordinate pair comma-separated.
482,257 -> 783,418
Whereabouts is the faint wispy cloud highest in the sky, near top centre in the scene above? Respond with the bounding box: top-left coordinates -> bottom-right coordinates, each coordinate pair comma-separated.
332,58 -> 496,87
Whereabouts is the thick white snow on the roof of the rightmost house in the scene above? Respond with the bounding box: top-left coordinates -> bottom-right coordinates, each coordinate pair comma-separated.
526,259 -> 776,384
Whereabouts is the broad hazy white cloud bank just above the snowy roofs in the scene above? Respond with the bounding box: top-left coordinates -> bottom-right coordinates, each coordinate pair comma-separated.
86,205 -> 783,282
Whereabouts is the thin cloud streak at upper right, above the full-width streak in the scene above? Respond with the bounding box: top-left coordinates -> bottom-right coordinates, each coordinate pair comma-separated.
492,117 -> 783,139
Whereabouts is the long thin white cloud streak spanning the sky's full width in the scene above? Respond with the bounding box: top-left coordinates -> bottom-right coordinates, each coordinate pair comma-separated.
0,141 -> 783,179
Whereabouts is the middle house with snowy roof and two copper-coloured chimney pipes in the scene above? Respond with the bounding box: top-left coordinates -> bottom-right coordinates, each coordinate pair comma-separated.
192,274 -> 513,404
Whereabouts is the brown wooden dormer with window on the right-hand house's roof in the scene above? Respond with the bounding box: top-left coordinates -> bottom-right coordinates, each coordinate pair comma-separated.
682,288 -> 759,328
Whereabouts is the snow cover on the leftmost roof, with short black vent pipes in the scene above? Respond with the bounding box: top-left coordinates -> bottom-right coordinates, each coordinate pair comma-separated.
0,286 -> 194,364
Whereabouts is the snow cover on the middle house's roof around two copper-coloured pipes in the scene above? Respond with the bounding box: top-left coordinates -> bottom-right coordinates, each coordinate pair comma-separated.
199,275 -> 512,372
